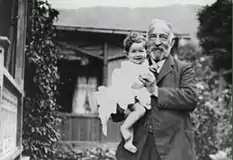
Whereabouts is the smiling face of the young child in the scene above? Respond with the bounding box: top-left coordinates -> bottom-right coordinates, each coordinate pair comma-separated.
128,43 -> 146,64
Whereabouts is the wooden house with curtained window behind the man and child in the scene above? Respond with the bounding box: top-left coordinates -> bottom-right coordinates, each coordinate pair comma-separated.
55,25 -> 190,143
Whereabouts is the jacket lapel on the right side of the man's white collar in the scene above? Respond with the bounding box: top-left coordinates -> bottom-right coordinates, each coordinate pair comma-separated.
156,55 -> 174,84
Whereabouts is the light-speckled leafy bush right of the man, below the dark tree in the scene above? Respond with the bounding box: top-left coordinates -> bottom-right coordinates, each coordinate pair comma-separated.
178,43 -> 232,160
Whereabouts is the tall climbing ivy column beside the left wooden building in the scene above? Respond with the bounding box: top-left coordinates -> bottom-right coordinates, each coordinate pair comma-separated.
23,0 -> 59,160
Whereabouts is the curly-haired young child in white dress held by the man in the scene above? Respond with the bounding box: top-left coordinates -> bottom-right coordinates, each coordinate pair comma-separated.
96,33 -> 152,153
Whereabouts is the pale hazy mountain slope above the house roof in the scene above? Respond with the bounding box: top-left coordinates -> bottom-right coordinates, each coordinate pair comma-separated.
55,4 -> 202,37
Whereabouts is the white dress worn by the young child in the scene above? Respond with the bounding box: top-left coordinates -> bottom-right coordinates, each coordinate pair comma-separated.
95,60 -> 151,135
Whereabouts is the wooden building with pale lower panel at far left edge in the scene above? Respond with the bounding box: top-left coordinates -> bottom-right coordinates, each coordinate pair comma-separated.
0,0 -> 27,160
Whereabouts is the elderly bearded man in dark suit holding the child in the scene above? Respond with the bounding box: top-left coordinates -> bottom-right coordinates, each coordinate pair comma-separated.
112,20 -> 197,160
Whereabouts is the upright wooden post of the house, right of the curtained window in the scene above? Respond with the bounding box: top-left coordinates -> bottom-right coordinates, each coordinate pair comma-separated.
103,40 -> 108,86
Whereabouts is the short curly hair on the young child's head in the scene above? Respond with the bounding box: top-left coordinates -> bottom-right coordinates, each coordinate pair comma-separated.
123,32 -> 147,53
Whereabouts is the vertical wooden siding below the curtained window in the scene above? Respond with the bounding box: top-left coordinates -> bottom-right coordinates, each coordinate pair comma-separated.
59,113 -> 121,143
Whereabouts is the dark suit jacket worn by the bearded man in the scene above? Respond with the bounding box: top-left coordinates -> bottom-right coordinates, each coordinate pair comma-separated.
113,56 -> 197,160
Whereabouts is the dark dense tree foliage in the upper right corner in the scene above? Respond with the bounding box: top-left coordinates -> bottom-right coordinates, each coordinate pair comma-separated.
197,0 -> 232,83
